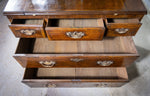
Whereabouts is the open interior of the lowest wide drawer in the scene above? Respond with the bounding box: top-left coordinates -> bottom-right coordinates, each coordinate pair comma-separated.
24,67 -> 128,80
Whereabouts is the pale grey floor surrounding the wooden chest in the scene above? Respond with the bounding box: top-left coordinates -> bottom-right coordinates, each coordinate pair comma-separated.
0,0 -> 150,96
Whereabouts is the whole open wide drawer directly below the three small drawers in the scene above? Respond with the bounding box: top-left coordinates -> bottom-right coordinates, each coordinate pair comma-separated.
14,37 -> 138,68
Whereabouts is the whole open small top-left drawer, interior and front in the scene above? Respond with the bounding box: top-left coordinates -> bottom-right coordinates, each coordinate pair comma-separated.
9,19 -> 45,38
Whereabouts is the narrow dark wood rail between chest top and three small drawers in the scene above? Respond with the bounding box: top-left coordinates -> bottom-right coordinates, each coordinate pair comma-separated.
7,14 -> 144,19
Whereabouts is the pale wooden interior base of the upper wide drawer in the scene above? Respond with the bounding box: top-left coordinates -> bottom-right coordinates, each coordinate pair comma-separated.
33,37 -> 136,54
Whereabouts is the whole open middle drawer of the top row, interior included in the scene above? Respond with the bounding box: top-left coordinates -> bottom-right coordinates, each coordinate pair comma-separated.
46,19 -> 105,40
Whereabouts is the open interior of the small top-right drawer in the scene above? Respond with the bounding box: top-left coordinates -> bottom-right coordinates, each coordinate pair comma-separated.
107,18 -> 139,24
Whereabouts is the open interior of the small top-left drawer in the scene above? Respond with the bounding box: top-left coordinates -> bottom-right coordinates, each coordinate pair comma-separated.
11,19 -> 43,25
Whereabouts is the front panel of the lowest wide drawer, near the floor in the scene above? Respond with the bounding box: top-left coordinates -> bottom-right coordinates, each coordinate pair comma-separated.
23,80 -> 127,88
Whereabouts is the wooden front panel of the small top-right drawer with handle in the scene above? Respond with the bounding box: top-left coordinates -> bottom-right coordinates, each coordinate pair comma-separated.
106,24 -> 141,37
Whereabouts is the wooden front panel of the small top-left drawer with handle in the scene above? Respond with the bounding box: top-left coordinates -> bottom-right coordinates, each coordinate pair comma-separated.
9,25 -> 45,38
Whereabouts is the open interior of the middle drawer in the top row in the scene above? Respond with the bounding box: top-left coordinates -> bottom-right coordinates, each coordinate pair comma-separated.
47,19 -> 104,28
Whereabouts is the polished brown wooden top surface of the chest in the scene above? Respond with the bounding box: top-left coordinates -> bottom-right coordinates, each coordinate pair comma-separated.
4,0 -> 146,15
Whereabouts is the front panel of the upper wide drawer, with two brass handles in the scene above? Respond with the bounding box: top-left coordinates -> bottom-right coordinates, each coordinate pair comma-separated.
14,54 -> 137,68
